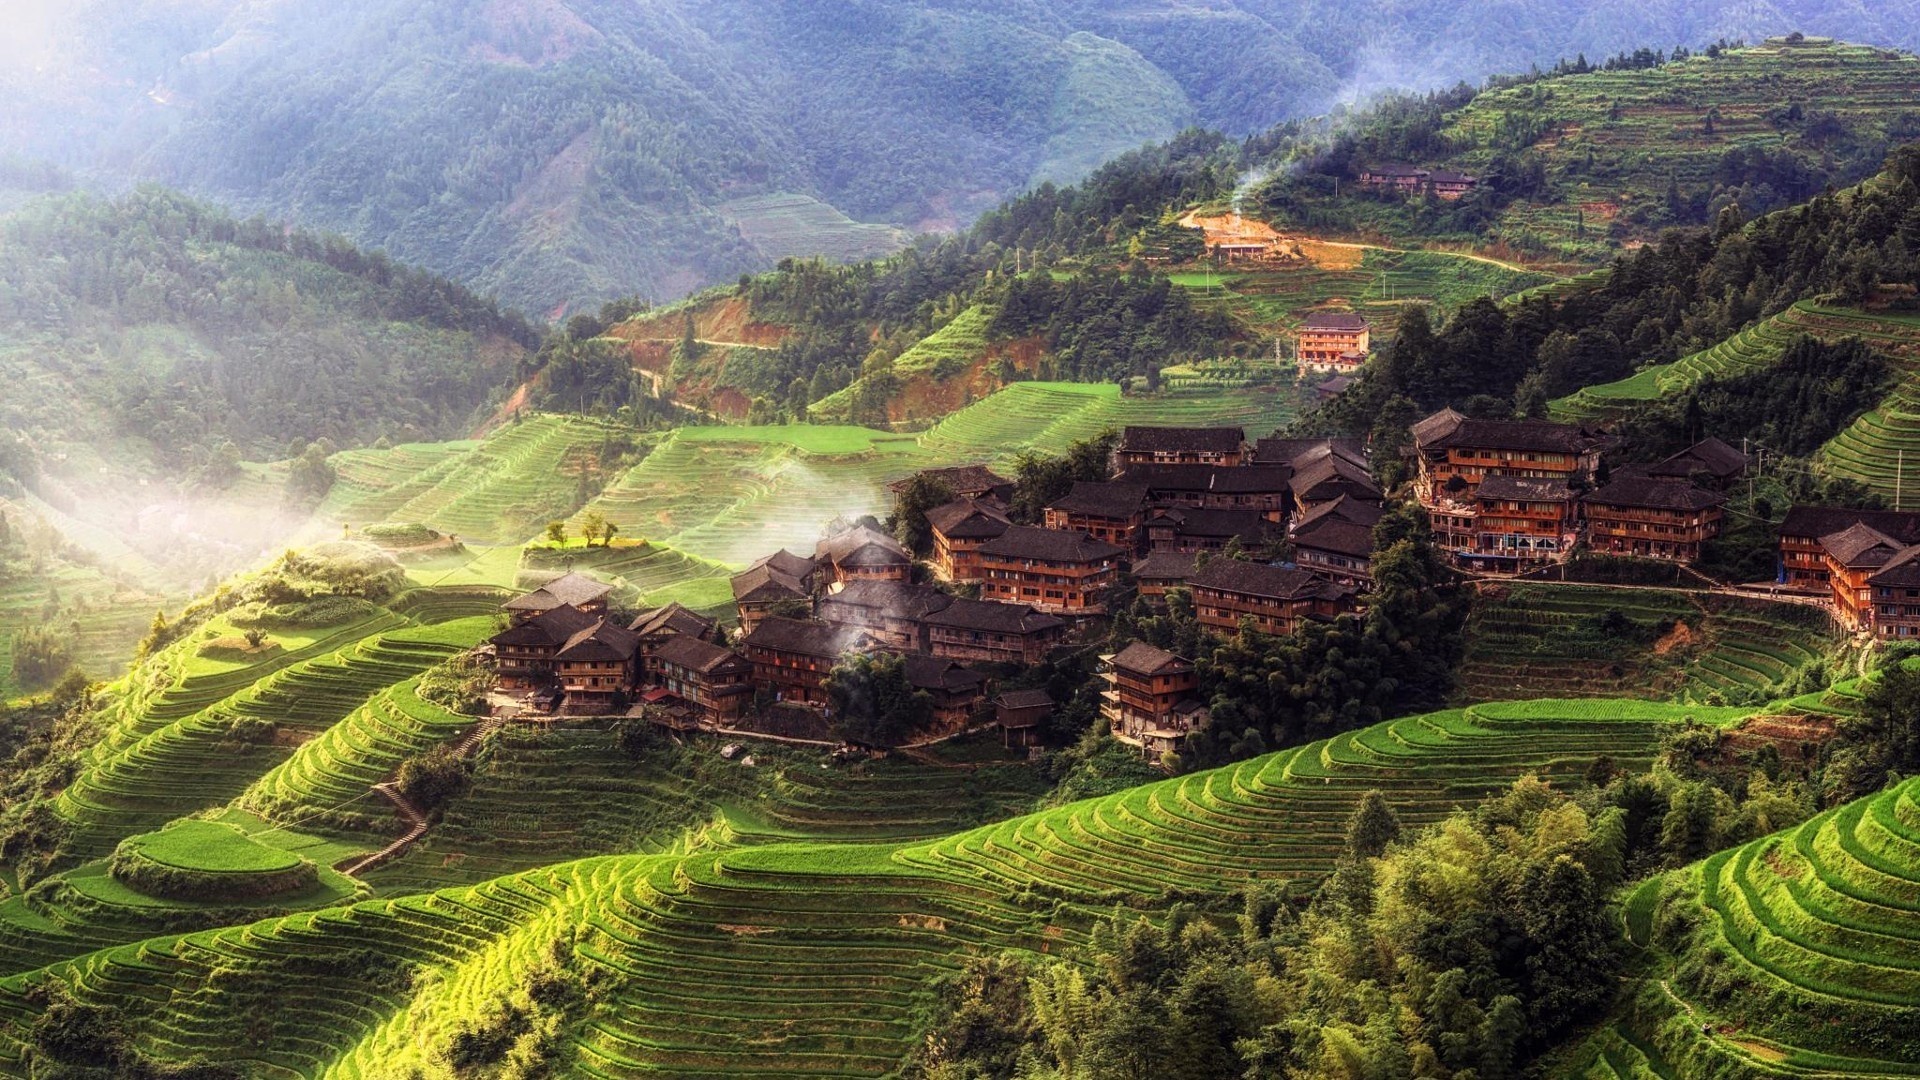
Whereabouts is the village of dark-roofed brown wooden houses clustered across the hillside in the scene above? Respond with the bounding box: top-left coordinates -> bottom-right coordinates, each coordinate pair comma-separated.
482,409 -> 1920,761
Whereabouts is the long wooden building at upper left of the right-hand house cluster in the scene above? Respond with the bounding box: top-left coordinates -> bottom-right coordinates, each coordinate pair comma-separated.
1413,409 -> 1605,509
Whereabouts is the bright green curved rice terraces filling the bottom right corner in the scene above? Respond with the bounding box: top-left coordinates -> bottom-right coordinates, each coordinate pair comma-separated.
1586,780 -> 1920,1078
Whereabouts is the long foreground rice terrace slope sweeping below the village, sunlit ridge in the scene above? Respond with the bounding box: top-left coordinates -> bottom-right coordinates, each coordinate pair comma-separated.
0,701 -> 1712,1078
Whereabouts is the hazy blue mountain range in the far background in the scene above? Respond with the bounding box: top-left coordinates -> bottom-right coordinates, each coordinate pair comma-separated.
0,0 -> 1920,313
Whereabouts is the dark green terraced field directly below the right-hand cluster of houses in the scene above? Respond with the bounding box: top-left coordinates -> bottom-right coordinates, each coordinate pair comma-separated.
1459,582 -> 1832,701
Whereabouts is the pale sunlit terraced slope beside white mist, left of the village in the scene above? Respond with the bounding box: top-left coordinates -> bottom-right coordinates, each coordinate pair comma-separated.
317,415 -> 612,542
